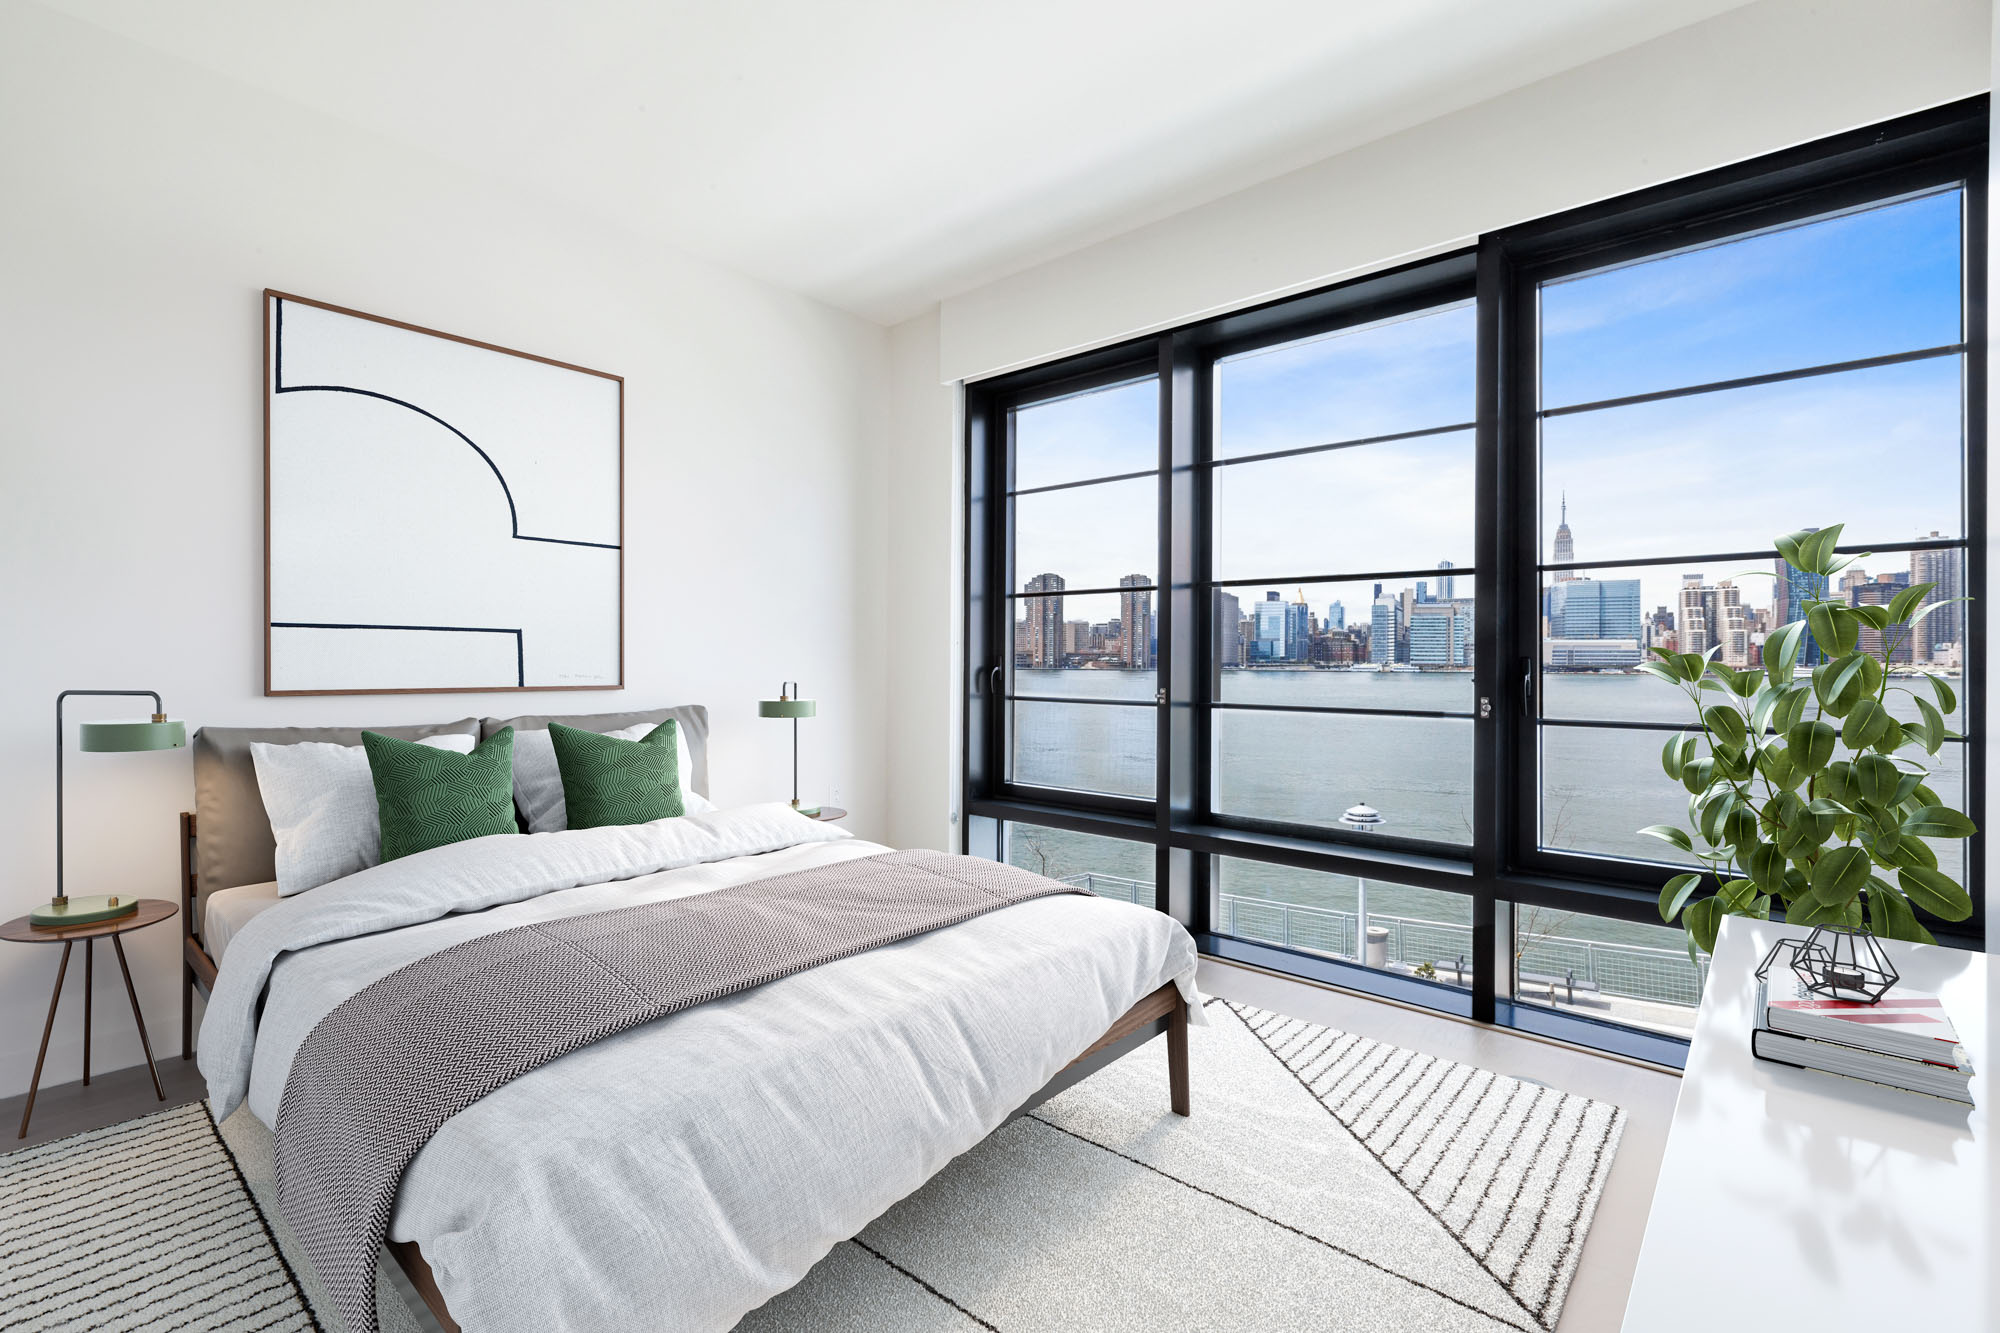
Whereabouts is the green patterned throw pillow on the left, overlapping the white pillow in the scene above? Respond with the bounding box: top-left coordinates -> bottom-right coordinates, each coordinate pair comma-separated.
362,727 -> 520,861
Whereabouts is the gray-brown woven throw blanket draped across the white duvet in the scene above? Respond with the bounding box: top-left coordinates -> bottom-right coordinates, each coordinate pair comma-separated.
276,851 -> 1084,1333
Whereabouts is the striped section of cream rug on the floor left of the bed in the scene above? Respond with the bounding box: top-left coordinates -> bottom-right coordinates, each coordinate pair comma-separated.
0,1103 -> 320,1333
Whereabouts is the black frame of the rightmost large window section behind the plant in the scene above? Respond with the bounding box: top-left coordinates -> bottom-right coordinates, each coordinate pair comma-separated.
1482,96 -> 1988,947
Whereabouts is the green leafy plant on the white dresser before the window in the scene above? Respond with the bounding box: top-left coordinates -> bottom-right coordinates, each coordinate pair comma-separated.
1640,526 -> 1974,959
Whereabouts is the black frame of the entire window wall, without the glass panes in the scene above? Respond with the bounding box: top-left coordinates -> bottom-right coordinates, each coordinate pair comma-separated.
960,96 -> 1988,1065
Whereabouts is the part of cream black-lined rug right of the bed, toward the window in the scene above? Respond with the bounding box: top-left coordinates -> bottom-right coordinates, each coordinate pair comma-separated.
738,1001 -> 1624,1333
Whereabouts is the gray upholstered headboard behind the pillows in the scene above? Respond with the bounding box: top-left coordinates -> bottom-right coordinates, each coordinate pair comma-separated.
188,705 -> 708,931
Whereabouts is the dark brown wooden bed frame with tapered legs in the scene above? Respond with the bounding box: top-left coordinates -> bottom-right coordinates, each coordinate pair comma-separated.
180,811 -> 1188,1333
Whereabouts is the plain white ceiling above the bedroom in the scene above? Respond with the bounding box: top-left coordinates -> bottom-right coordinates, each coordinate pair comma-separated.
48,0 -> 1744,322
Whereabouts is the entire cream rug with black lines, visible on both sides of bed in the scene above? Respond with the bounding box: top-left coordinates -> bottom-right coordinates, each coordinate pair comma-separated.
0,1001 -> 1624,1333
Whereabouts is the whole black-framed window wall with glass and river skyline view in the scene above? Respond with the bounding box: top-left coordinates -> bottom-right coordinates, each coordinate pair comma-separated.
966,102 -> 1986,1059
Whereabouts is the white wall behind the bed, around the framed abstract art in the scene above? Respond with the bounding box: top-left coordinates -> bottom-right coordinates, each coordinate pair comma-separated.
0,4 -> 892,1097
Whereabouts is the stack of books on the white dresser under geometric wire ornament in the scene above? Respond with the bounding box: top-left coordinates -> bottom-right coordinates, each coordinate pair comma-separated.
1750,967 -> 1972,1107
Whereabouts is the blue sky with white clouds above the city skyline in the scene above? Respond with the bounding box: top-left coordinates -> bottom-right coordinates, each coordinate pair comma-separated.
1016,192 -> 1962,610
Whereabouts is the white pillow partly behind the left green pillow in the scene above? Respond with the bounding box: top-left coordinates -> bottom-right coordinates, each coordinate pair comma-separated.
250,737 -> 478,897
